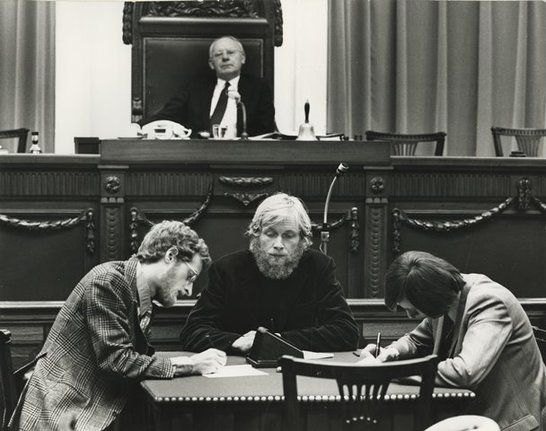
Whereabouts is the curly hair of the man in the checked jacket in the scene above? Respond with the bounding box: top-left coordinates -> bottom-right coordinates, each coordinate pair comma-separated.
136,220 -> 210,266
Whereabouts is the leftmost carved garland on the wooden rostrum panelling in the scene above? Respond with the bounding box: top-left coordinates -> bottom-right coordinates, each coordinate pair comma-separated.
0,208 -> 95,254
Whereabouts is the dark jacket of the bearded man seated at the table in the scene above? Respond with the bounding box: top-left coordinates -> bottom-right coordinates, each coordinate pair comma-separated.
181,250 -> 358,352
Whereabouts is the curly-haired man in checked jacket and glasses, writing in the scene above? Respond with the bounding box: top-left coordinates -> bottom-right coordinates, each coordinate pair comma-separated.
10,221 -> 226,431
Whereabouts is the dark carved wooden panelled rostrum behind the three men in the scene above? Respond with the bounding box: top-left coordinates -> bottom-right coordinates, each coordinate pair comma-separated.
0,140 -> 546,365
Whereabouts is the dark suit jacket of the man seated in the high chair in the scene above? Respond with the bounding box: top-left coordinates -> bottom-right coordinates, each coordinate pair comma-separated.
141,74 -> 276,137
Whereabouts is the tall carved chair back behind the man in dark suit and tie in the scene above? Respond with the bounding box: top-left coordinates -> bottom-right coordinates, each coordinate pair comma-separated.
123,0 -> 282,122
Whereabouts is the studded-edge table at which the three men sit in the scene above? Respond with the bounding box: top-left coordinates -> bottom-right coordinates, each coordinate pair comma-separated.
141,352 -> 474,431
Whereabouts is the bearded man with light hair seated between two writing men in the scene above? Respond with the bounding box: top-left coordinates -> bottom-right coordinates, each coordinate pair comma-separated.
181,193 -> 359,354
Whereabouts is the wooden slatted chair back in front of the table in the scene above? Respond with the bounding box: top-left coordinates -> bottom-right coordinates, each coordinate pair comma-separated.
280,355 -> 438,431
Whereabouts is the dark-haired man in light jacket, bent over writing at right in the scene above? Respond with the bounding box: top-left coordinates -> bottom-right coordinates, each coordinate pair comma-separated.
361,251 -> 546,431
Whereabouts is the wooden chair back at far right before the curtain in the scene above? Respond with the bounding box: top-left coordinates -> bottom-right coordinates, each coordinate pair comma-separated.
491,127 -> 546,157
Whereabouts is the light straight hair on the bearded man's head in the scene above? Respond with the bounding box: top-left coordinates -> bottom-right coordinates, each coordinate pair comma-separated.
246,193 -> 313,249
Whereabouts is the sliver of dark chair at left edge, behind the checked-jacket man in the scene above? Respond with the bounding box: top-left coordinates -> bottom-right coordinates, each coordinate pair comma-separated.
0,329 -> 17,430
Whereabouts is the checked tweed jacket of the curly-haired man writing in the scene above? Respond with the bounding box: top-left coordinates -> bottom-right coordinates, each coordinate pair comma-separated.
10,258 -> 174,431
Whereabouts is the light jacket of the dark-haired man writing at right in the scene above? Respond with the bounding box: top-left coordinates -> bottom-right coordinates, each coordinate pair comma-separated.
393,274 -> 546,431
